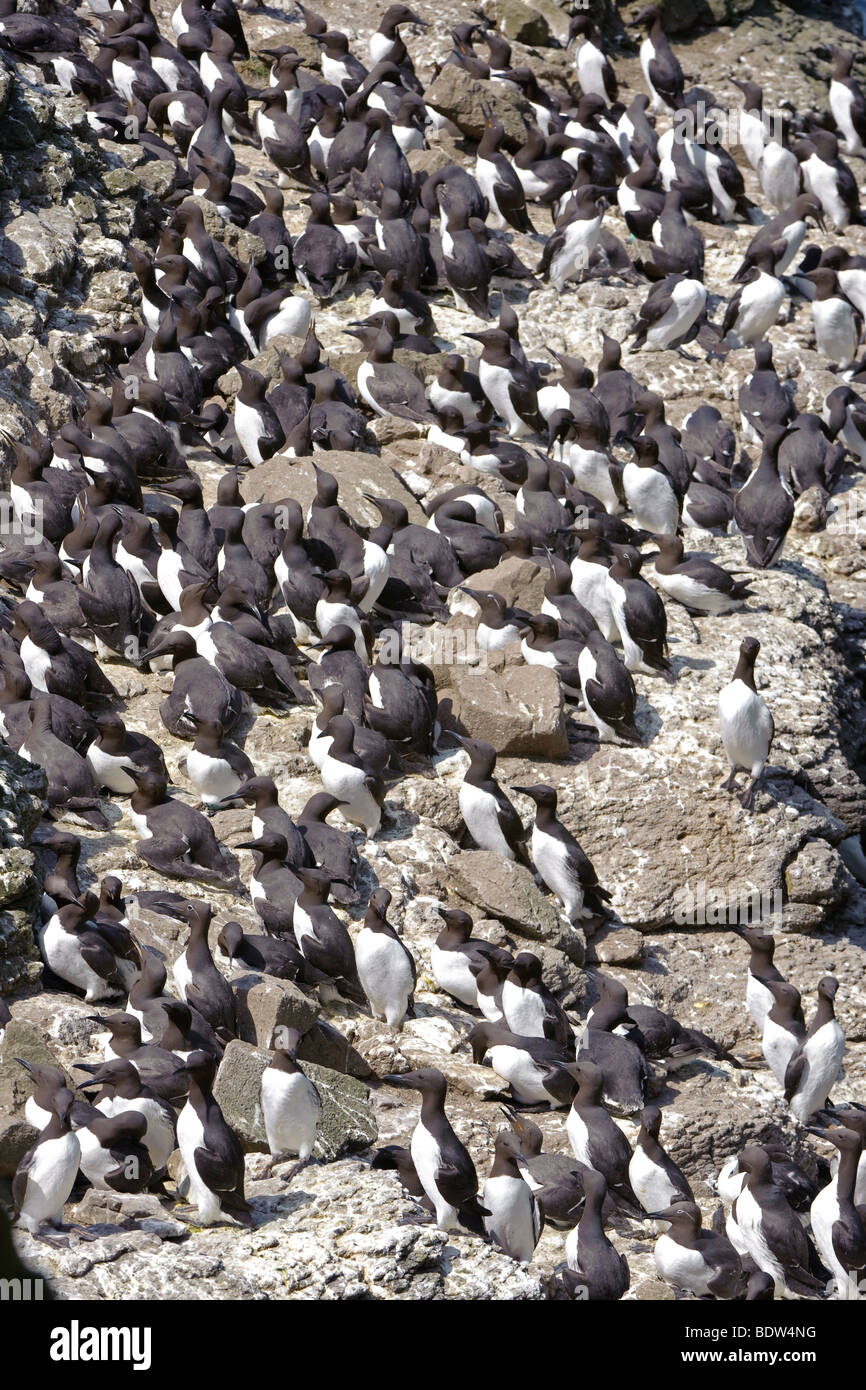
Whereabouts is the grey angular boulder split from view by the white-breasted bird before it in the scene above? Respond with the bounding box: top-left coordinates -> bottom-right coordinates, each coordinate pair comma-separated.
214,1041 -> 378,1161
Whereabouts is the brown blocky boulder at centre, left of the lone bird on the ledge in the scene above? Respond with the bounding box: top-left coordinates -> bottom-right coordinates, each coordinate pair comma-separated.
439,664 -> 569,758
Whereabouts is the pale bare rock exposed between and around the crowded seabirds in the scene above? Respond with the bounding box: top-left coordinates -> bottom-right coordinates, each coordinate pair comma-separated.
0,0 -> 866,1300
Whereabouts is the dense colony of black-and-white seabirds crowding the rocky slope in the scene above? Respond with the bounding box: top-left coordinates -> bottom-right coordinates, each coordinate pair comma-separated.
0,0 -> 866,1301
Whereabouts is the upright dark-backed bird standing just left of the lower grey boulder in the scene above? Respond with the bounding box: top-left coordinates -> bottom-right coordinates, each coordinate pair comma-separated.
178,1052 -> 253,1226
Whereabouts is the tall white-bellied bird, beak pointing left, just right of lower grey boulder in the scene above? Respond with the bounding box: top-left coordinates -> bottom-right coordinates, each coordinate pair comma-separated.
382,1068 -> 491,1236
